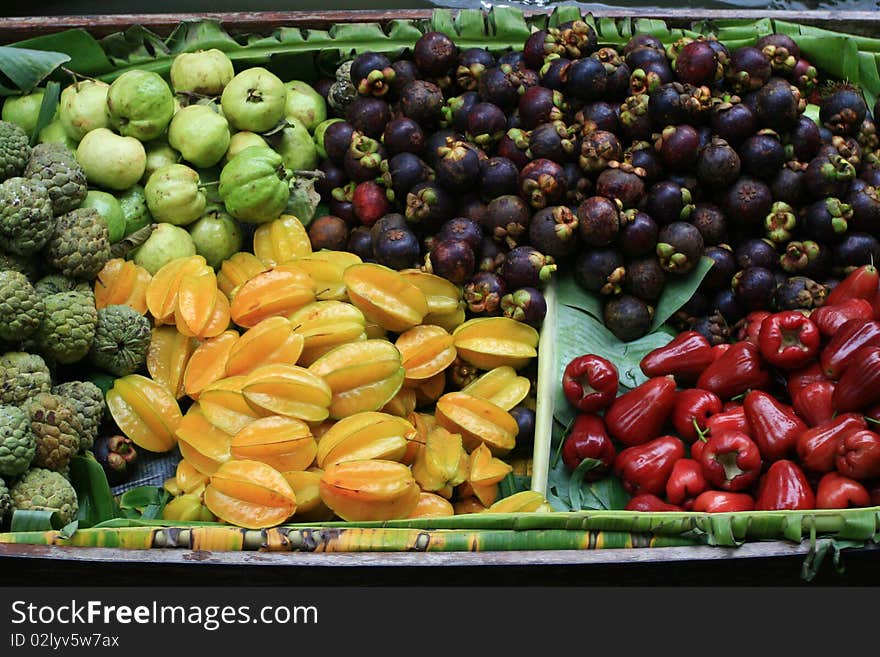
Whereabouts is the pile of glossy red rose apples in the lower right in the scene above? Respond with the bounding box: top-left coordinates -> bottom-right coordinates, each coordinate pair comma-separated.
562,265 -> 880,512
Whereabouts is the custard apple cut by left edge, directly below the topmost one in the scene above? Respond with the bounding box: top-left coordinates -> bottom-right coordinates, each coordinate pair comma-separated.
0,177 -> 55,256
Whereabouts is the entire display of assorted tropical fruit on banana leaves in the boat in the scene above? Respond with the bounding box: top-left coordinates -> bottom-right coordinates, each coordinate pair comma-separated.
0,10 -> 880,548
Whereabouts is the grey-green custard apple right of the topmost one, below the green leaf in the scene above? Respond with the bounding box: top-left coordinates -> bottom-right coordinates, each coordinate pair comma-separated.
24,143 -> 88,215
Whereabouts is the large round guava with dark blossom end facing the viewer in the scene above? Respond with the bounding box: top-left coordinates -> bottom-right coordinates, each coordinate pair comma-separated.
220,66 -> 287,132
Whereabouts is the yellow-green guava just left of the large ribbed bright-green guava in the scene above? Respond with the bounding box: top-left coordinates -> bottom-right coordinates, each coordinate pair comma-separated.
144,164 -> 207,226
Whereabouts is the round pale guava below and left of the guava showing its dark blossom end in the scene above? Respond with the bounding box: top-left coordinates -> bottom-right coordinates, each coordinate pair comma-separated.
168,105 -> 230,167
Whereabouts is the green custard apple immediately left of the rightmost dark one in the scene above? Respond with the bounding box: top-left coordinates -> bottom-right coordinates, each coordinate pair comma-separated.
33,292 -> 98,365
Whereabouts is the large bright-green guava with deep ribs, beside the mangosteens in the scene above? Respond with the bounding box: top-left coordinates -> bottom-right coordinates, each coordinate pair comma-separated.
220,146 -> 290,224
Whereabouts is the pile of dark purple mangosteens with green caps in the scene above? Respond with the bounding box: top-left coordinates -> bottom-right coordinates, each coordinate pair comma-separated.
310,21 -> 880,342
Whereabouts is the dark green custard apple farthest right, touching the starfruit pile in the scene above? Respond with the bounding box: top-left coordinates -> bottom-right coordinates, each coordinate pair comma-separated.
89,305 -> 152,376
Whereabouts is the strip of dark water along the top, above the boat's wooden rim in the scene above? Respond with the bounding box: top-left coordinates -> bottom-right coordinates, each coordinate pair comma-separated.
0,0 -> 880,16
